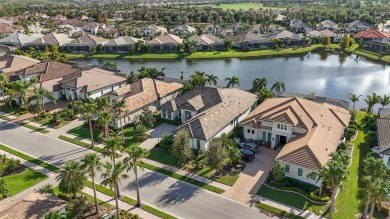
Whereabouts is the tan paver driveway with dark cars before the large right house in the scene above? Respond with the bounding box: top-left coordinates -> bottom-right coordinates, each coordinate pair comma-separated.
223,147 -> 279,205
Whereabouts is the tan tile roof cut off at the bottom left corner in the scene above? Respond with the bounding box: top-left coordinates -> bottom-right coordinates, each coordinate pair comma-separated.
0,191 -> 67,219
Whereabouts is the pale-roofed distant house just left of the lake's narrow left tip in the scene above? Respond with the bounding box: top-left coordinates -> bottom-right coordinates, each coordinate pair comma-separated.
25,33 -> 73,50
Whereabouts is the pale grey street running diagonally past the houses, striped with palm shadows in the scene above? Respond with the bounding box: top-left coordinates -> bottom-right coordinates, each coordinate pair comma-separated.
0,122 -> 269,219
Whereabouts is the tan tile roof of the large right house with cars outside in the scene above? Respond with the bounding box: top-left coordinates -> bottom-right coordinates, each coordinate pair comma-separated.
240,97 -> 350,169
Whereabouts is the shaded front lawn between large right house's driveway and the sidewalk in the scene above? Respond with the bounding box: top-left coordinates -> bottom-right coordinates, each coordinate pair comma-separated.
257,185 -> 328,214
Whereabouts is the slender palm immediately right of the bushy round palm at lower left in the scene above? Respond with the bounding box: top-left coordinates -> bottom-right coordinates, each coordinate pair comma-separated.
80,153 -> 102,215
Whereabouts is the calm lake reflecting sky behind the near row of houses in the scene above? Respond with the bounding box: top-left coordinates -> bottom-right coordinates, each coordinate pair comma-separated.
72,52 -> 390,108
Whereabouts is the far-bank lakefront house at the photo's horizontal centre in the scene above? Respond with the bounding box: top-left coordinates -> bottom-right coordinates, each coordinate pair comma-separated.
189,34 -> 225,51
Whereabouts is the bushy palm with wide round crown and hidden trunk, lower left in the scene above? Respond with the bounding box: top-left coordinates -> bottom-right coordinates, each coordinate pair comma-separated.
56,160 -> 87,197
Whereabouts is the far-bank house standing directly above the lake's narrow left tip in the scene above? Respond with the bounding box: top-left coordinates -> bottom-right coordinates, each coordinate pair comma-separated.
64,34 -> 109,52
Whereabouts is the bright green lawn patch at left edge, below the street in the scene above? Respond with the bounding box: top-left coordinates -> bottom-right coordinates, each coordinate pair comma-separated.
3,168 -> 48,196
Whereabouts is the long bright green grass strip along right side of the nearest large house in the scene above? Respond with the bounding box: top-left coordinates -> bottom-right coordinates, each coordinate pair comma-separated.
334,111 -> 385,219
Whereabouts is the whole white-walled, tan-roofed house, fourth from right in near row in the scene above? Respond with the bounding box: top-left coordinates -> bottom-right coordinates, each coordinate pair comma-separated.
59,68 -> 126,100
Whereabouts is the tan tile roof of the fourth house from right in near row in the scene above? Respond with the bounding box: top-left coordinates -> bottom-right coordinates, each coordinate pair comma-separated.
60,68 -> 126,92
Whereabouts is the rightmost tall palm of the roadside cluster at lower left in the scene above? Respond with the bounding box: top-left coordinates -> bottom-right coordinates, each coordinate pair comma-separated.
123,145 -> 149,206
